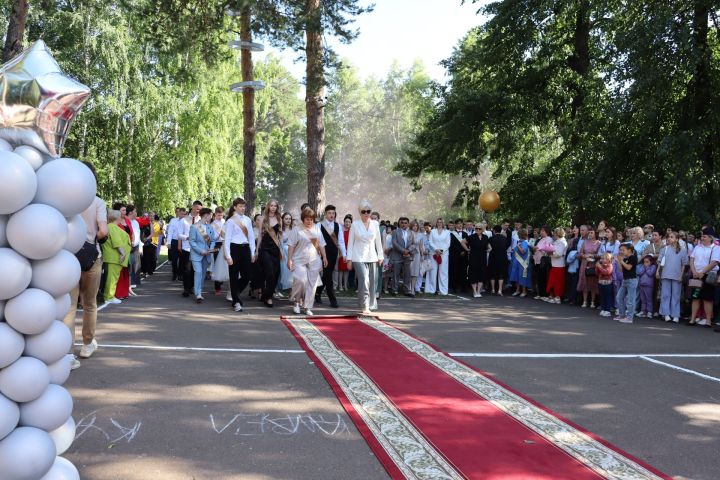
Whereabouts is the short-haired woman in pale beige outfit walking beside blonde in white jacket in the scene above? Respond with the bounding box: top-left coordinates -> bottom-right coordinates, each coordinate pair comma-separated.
288,207 -> 327,315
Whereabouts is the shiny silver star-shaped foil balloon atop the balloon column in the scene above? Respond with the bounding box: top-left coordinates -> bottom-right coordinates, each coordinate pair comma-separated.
0,40 -> 90,157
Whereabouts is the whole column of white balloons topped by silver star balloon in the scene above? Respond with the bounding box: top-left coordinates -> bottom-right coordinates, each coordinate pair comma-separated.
0,41 -> 96,480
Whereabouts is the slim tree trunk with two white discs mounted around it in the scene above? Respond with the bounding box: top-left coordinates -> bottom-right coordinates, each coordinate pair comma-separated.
240,6 -> 257,215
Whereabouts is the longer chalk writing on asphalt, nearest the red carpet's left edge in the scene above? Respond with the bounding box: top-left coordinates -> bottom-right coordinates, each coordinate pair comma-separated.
210,413 -> 350,437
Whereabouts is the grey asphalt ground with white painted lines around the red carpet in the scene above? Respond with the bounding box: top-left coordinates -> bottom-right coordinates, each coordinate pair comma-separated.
66,265 -> 720,480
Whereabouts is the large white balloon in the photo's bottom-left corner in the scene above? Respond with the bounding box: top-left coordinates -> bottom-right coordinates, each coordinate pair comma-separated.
0,427 -> 55,480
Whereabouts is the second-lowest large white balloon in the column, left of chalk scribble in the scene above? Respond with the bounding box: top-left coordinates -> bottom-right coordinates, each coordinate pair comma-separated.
20,384 -> 73,432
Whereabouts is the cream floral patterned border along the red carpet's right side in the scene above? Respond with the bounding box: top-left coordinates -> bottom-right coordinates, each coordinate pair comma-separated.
358,316 -> 670,480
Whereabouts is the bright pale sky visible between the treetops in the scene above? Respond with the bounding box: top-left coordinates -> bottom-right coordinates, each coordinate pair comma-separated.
259,0 -> 487,82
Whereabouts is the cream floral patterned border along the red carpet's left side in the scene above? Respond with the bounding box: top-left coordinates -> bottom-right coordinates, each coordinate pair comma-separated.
283,316 -> 464,480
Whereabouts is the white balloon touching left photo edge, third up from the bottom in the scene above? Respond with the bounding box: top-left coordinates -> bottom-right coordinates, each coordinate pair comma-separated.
0,357 -> 50,402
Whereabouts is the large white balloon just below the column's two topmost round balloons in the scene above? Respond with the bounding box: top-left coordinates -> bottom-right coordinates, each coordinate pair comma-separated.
7,203 -> 68,260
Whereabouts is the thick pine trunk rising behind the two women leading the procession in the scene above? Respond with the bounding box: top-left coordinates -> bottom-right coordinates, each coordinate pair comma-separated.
305,0 -> 325,211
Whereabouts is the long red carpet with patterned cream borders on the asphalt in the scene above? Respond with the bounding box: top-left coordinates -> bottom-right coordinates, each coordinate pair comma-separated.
283,317 -> 670,480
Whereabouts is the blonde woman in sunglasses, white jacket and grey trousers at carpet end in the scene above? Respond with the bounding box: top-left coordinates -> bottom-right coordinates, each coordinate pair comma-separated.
347,200 -> 384,315
